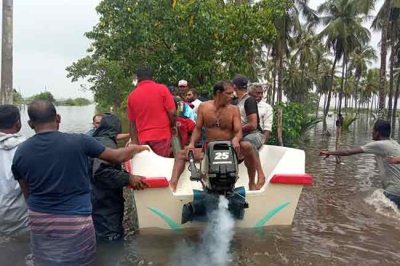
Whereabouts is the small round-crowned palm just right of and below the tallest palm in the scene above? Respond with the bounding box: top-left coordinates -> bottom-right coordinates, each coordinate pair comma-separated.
350,45 -> 378,113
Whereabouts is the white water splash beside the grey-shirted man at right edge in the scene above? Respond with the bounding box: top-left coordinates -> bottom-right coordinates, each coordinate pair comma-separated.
365,189 -> 400,219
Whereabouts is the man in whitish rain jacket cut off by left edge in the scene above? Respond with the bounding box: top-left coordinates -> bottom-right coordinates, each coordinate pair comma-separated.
0,105 -> 29,235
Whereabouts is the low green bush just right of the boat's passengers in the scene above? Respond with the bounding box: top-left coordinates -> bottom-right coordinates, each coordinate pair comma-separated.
269,102 -> 321,147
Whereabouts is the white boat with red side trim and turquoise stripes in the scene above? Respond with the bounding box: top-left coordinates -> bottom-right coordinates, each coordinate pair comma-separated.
125,145 -> 312,230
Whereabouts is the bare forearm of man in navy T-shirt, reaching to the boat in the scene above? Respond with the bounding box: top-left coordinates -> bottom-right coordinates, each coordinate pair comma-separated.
98,145 -> 149,163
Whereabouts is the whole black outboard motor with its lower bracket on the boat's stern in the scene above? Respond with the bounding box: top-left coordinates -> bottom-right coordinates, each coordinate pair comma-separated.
182,141 -> 248,224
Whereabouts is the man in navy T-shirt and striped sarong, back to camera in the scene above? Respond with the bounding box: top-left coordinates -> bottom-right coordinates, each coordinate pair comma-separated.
12,101 -> 147,266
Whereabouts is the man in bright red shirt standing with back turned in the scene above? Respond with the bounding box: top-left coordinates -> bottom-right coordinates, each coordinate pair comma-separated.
128,66 -> 176,157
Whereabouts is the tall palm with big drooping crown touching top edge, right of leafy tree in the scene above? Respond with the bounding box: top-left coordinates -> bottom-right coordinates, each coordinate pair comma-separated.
318,0 -> 370,131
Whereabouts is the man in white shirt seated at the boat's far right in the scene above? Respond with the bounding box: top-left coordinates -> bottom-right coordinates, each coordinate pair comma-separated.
249,84 -> 274,142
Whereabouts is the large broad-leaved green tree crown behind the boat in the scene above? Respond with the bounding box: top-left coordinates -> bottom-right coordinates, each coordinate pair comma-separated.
67,0 -> 285,106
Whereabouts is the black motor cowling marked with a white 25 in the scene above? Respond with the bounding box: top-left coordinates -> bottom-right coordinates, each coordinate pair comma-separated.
200,141 -> 238,195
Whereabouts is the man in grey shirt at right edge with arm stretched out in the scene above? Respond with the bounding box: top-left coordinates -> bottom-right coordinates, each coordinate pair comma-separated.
320,120 -> 400,207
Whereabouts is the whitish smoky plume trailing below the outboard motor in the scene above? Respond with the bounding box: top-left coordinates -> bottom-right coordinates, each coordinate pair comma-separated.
173,196 -> 235,266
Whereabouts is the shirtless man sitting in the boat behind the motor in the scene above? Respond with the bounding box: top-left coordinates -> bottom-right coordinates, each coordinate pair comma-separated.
169,81 -> 241,192
